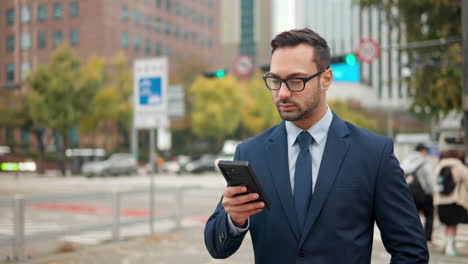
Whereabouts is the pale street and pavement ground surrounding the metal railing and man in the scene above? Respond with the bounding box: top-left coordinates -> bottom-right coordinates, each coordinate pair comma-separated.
0,173 -> 468,264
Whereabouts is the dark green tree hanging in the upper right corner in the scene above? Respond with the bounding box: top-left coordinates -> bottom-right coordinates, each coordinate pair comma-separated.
358,0 -> 462,119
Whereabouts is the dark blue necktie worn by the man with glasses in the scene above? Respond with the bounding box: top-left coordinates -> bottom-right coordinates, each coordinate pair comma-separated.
294,131 -> 313,228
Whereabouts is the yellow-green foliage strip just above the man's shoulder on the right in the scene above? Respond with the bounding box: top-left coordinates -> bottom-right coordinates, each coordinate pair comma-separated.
328,100 -> 379,132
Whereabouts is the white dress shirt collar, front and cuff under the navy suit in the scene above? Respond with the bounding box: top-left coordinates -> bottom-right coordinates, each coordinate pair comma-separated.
228,106 -> 333,236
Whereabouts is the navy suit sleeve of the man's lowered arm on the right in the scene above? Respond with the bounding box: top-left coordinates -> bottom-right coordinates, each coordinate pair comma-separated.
374,139 -> 429,264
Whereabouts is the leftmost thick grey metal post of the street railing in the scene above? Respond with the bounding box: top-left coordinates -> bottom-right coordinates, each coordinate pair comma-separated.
13,194 -> 27,261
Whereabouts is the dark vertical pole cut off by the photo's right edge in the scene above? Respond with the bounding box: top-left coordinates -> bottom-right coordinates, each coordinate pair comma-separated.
461,0 -> 468,164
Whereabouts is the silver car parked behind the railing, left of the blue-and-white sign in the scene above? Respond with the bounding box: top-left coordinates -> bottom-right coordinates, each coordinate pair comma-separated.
82,153 -> 138,177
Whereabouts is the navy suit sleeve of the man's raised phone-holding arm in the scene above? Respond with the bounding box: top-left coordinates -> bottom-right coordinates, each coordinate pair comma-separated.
205,146 -> 247,259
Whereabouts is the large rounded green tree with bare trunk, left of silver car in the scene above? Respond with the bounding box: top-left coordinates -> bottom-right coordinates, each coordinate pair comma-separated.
27,45 -> 95,175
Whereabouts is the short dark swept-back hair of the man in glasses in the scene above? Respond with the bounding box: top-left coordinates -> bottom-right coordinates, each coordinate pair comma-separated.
271,28 -> 330,71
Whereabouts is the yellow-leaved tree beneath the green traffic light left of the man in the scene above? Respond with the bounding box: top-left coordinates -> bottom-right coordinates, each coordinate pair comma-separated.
190,76 -> 242,151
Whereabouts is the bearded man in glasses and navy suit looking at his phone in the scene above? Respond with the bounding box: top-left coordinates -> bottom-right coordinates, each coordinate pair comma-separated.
205,29 -> 429,264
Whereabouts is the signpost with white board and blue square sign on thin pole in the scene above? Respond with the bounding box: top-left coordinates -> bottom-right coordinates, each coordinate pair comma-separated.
132,57 -> 169,233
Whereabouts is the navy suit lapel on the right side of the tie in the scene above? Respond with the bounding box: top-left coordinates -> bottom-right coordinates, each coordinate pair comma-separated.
301,114 -> 349,244
